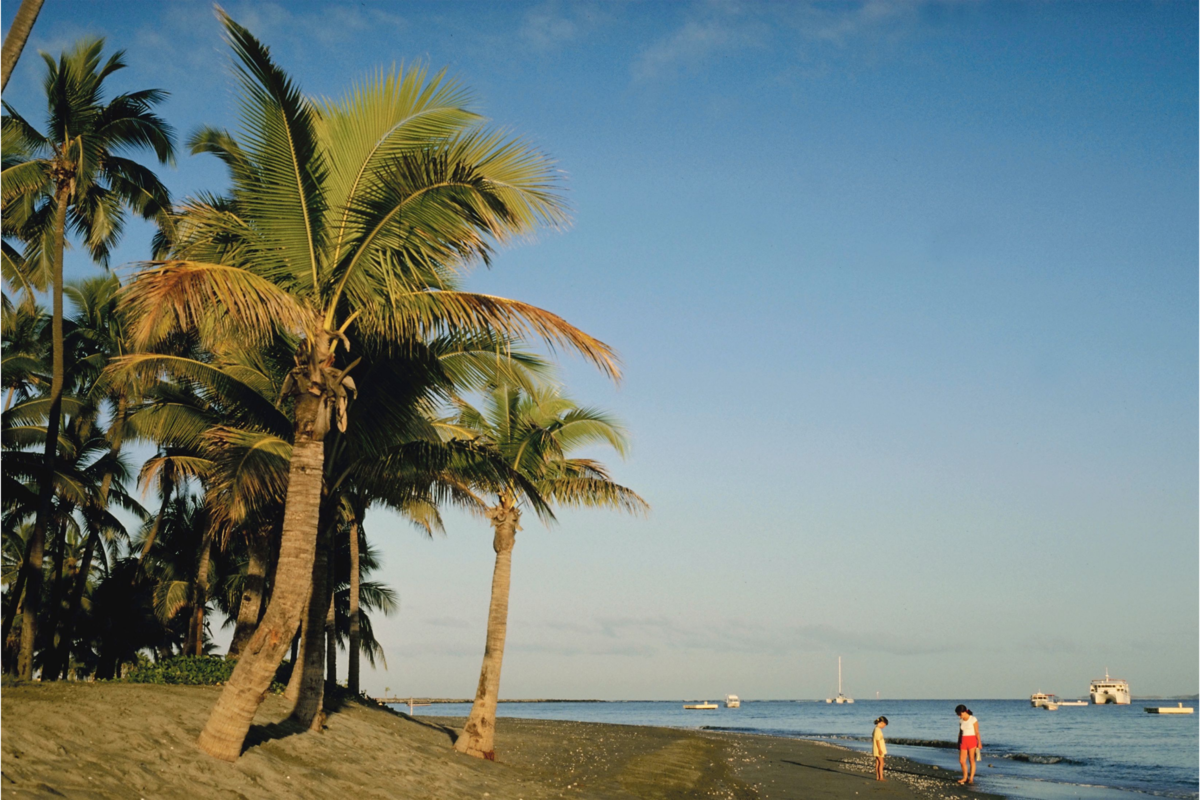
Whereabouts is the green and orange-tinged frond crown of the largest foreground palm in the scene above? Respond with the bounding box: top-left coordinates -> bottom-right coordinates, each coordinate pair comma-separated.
128,12 -> 618,377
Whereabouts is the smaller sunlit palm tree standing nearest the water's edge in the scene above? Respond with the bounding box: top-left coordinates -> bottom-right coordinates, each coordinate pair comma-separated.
455,385 -> 649,759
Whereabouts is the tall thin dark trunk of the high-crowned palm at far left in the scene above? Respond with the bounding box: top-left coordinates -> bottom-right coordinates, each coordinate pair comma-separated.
17,184 -> 74,680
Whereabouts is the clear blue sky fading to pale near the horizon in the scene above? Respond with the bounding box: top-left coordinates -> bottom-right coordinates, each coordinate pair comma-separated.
2,0 -> 1200,698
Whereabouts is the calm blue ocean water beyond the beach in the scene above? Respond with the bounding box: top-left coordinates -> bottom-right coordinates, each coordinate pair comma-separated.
405,698 -> 1200,800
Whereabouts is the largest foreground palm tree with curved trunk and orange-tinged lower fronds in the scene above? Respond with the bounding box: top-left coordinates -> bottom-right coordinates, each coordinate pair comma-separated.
119,13 -> 617,760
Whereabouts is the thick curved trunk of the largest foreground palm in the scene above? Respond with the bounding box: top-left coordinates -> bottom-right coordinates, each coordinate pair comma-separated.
199,333 -> 354,762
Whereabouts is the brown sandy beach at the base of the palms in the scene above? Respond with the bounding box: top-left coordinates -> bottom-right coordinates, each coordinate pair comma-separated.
0,684 -> 998,800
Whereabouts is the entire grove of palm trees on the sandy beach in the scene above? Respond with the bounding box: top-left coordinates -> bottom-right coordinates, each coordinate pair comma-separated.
0,10 -> 648,762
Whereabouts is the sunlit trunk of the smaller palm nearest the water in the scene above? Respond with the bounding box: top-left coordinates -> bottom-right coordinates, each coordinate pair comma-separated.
454,503 -> 521,760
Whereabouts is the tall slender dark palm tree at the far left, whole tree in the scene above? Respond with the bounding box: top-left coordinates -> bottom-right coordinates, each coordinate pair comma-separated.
0,38 -> 174,680
